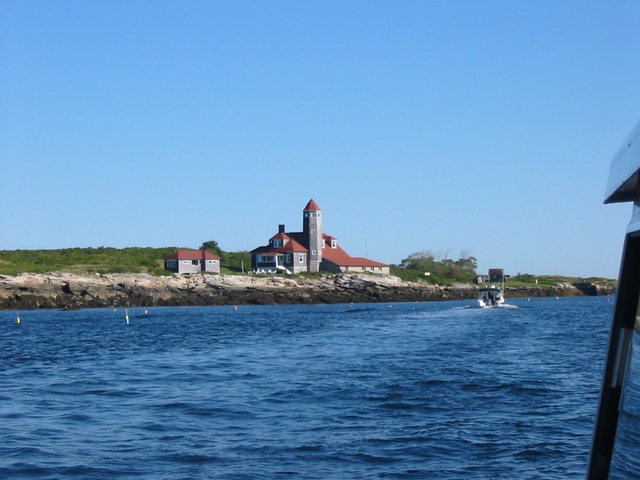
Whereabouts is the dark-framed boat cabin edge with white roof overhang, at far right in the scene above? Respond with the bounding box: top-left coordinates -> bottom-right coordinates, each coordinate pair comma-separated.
587,119 -> 640,479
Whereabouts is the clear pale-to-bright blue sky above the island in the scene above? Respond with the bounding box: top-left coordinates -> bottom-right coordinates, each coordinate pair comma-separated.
0,0 -> 640,278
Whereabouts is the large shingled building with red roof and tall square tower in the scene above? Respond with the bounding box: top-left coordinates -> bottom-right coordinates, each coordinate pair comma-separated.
251,199 -> 389,274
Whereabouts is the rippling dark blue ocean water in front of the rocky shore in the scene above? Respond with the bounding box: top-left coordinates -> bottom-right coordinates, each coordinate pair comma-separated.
0,297 -> 632,479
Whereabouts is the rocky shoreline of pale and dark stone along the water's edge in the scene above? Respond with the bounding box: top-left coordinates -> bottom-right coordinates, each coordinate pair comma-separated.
0,273 -> 614,310
